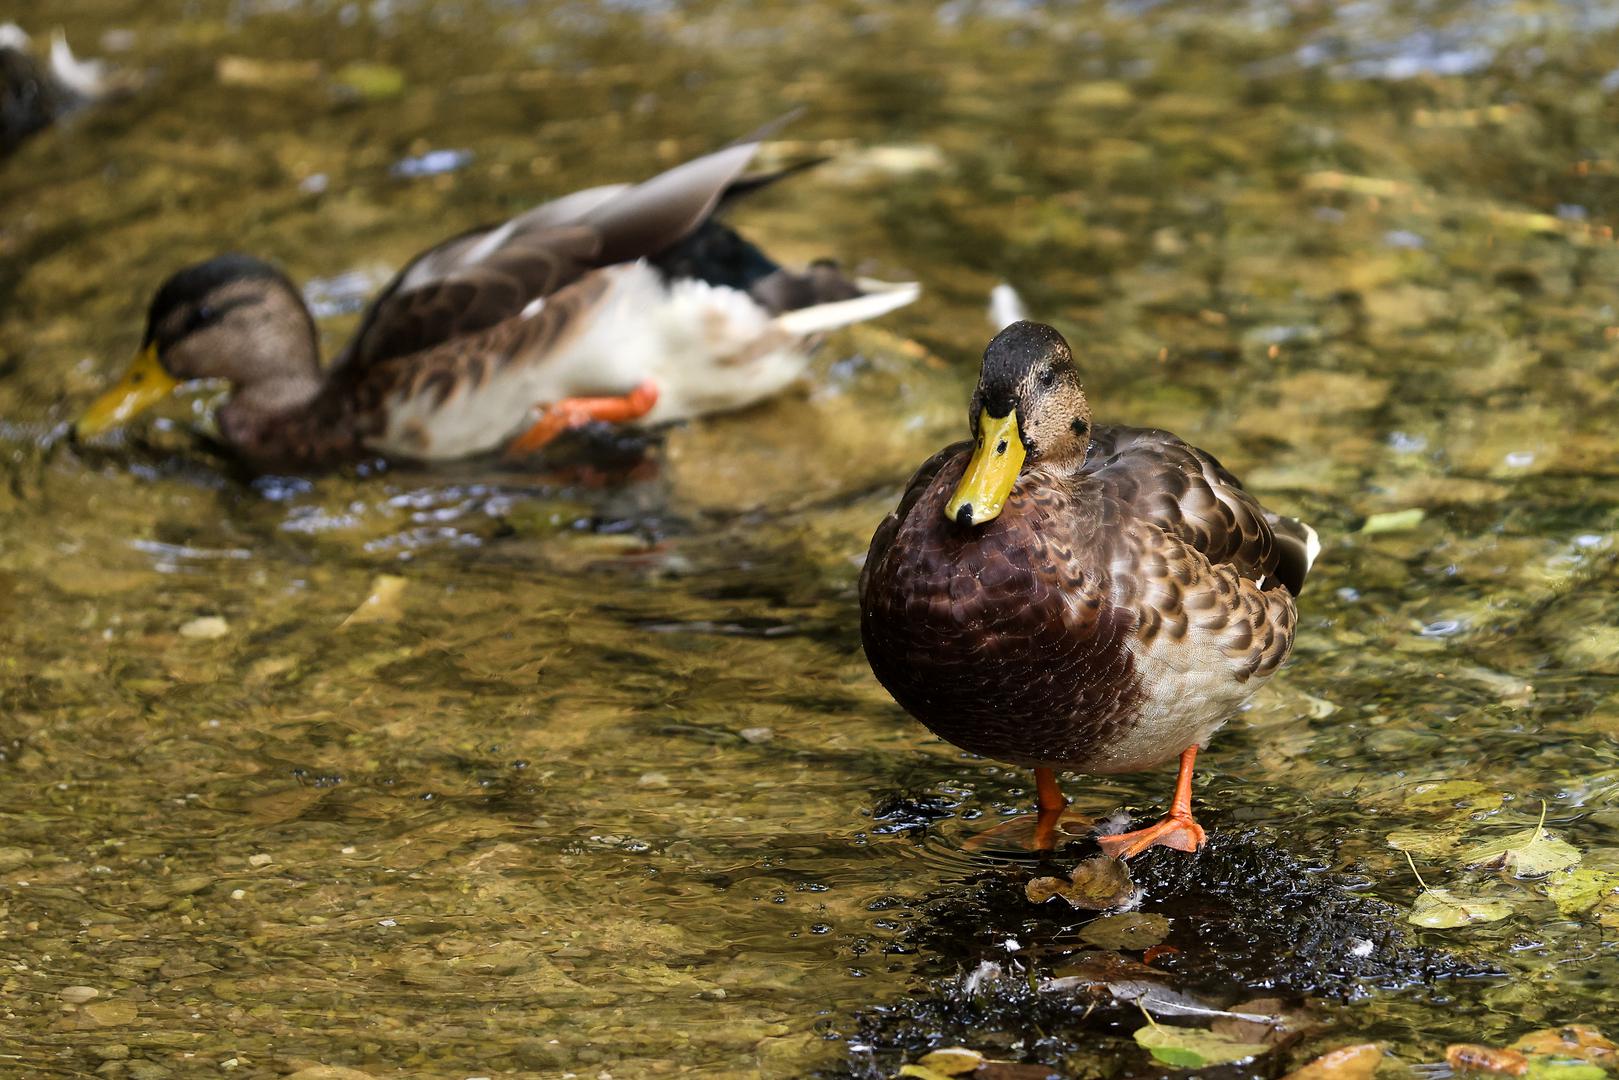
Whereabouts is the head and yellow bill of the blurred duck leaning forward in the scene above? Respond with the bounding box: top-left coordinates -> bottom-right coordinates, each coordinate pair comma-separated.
74,254 -> 321,437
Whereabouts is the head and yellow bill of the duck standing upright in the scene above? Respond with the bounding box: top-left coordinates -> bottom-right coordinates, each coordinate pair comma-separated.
944,322 -> 1091,526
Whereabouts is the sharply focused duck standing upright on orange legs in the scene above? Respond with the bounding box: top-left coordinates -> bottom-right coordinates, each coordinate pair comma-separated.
860,319 -> 1321,860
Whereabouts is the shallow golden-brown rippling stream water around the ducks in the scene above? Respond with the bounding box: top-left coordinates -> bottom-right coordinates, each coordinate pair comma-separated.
0,0 -> 1619,1077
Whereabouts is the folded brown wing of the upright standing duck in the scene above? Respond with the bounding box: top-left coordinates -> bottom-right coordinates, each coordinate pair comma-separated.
1081,426 -> 1318,596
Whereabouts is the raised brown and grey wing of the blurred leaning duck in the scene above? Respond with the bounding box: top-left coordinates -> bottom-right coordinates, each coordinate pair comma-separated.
332,136 -> 777,374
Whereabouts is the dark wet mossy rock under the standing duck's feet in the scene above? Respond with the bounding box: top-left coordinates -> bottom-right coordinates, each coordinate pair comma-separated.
831,831 -> 1496,1078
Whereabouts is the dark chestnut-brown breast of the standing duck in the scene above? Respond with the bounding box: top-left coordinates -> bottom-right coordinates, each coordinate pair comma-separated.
861,444 -> 1140,769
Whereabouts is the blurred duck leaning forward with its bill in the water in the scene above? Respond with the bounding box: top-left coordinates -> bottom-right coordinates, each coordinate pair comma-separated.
73,125 -> 920,473
